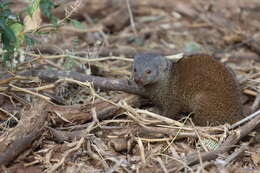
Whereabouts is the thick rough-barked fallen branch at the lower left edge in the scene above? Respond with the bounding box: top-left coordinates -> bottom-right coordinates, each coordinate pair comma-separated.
0,103 -> 47,165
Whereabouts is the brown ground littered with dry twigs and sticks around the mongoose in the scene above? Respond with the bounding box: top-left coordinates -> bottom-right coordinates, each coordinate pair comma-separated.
0,0 -> 260,173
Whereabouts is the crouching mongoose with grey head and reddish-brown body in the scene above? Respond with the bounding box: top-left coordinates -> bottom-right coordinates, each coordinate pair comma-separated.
132,53 -> 242,126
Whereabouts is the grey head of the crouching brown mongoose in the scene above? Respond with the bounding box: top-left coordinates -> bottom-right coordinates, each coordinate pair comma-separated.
132,53 -> 169,86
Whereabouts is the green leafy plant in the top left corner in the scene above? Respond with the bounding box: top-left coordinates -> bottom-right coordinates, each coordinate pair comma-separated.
0,0 -> 57,64
